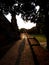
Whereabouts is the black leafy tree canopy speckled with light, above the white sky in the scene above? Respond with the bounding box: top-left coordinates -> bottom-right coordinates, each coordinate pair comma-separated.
0,0 -> 49,22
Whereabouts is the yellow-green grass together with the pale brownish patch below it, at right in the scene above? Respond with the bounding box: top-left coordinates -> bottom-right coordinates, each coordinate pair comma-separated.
31,34 -> 47,50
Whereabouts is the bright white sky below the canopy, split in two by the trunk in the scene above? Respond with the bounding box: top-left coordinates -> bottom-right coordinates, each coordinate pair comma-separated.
5,13 -> 36,29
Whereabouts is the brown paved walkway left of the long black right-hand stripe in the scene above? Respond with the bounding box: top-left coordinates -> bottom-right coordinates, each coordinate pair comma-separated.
0,40 -> 34,65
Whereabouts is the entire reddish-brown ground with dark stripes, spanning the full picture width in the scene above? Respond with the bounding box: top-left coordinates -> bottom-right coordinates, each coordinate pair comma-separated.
0,34 -> 49,65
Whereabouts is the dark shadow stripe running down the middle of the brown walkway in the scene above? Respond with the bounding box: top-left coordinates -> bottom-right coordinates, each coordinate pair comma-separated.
15,39 -> 25,65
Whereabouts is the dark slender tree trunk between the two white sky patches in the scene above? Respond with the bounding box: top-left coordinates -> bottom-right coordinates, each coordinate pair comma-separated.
11,13 -> 20,39
